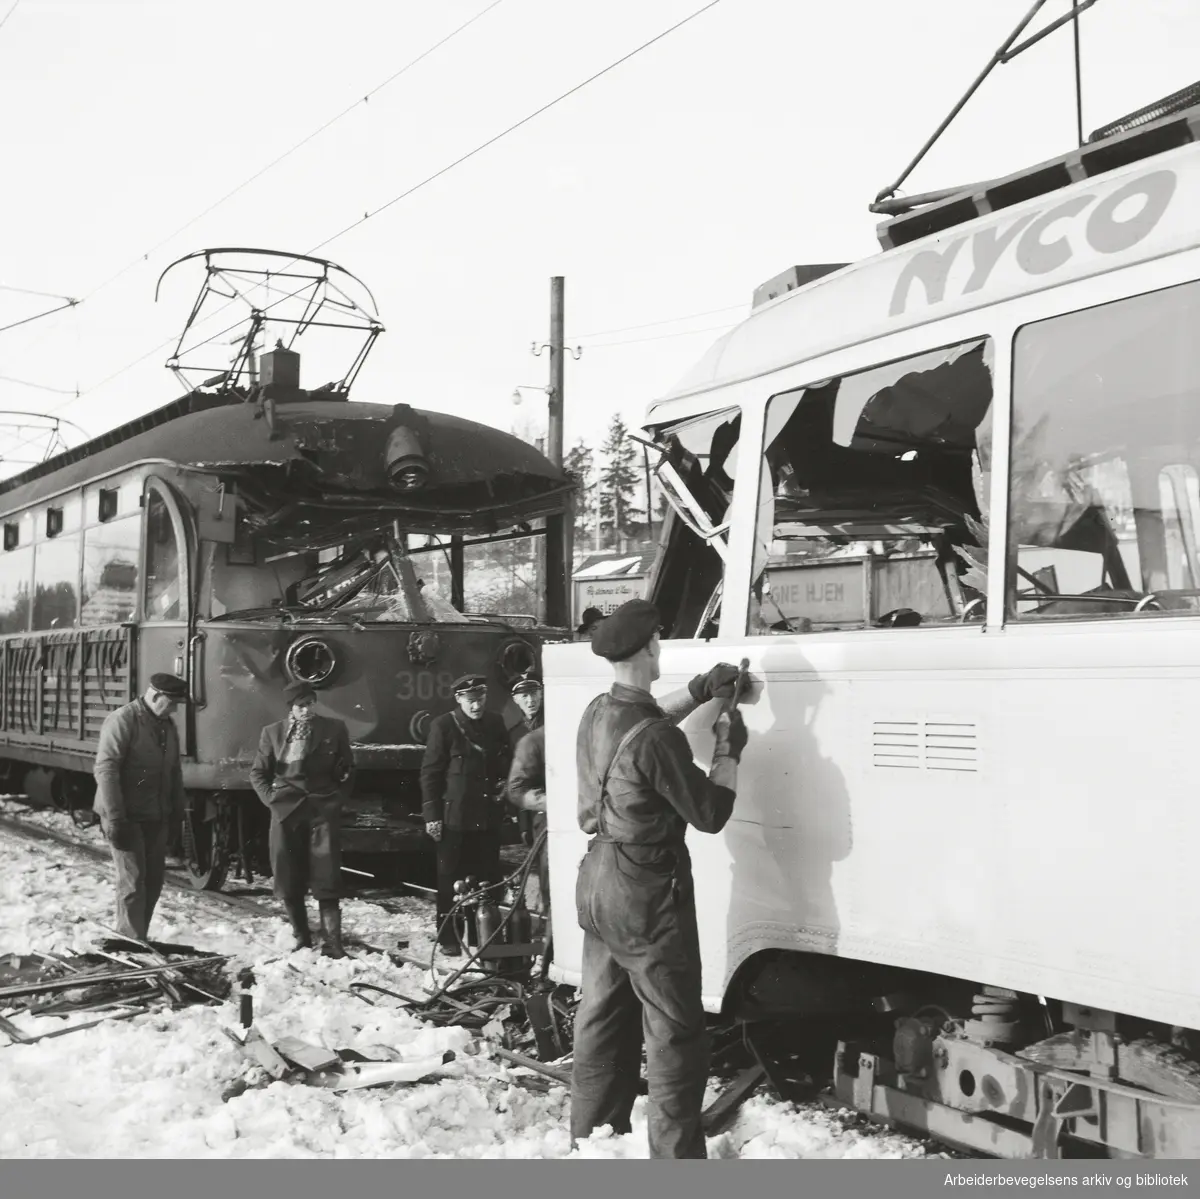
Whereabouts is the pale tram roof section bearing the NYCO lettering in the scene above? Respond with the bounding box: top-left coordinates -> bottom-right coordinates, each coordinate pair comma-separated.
646,107 -> 1200,425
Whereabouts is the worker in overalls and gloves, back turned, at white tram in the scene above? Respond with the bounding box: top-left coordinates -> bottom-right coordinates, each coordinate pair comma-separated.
571,599 -> 746,1157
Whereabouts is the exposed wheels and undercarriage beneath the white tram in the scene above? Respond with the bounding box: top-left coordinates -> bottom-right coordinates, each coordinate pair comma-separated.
730,953 -> 1200,1159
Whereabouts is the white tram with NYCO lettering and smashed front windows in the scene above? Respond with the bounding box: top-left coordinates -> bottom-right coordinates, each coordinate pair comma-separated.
545,93 -> 1200,1157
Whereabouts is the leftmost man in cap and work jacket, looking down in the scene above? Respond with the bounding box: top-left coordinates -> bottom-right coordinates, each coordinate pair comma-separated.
92,675 -> 187,941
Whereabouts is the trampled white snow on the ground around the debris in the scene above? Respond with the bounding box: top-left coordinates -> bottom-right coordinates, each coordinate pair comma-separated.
0,801 -> 924,1158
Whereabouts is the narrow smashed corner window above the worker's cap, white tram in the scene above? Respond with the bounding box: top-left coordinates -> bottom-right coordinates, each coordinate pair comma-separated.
649,408 -> 742,637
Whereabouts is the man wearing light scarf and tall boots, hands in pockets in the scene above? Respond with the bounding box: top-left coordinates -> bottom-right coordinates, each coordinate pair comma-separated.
250,683 -> 354,958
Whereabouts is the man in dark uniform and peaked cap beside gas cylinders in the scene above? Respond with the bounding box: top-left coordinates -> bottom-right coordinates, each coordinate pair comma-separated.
421,675 -> 511,954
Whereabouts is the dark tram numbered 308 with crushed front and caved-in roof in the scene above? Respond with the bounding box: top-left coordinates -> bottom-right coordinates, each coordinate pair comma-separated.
0,250 -> 571,889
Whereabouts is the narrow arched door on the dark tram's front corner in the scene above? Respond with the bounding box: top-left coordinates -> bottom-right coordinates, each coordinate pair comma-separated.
137,475 -> 196,755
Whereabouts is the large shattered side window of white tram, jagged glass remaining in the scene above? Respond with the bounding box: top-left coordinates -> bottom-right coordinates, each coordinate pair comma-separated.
749,338 -> 992,635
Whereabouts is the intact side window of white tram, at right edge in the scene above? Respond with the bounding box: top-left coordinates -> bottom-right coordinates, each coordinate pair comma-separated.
1006,276 -> 1200,621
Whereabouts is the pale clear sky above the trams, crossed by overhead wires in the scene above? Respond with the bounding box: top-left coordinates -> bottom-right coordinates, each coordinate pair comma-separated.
0,0 -> 1200,475
